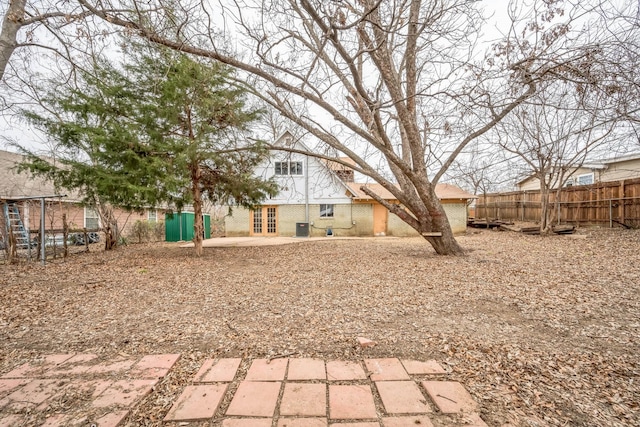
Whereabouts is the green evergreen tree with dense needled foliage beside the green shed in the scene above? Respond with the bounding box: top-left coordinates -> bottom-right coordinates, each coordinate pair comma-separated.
23,44 -> 277,255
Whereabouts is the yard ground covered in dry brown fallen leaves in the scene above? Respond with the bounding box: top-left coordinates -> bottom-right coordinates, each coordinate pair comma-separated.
0,229 -> 640,426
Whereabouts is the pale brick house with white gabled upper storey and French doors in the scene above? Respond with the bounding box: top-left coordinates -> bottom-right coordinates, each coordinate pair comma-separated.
225,132 -> 475,236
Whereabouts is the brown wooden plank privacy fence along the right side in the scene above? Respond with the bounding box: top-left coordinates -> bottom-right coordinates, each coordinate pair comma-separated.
475,178 -> 640,228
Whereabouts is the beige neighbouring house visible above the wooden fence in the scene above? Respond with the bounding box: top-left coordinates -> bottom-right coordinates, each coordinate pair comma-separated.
516,153 -> 640,191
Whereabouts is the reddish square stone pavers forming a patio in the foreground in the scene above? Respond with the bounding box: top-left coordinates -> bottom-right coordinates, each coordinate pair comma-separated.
0,354 -> 486,427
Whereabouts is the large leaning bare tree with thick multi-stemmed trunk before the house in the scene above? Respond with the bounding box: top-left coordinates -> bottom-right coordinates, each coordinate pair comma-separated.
5,0 -> 640,254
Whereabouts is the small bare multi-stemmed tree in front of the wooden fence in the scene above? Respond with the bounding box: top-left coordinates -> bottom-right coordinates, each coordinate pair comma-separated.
497,82 -> 618,233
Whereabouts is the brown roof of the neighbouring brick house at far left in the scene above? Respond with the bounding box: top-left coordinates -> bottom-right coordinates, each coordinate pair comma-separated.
0,150 -> 79,200
